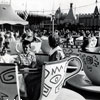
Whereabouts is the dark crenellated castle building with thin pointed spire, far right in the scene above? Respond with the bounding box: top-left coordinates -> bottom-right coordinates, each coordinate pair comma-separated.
78,1 -> 100,31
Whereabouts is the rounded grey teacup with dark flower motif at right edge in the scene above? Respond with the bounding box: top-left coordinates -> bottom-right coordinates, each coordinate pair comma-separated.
80,51 -> 100,85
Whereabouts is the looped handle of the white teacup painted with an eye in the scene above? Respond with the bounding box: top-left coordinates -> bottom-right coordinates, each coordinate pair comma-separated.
64,56 -> 83,85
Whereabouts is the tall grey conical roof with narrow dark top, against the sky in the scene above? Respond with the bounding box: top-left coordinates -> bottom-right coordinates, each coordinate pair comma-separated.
65,3 -> 75,23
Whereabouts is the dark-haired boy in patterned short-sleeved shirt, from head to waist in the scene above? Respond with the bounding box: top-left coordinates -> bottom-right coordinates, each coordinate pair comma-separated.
16,40 -> 36,68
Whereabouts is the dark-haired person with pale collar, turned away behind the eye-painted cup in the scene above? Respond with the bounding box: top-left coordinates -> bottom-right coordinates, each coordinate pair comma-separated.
48,34 -> 65,61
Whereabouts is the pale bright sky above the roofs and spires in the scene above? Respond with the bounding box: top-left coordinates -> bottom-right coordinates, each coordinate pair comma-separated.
0,0 -> 100,14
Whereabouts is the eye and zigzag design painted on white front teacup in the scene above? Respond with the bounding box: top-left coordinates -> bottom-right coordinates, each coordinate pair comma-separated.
43,65 -> 66,97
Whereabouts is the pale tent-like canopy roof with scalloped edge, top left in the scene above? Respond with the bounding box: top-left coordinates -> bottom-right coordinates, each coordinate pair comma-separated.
0,4 -> 28,25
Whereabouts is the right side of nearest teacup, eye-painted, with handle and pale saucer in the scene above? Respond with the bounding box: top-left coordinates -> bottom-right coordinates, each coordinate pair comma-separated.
18,54 -> 84,100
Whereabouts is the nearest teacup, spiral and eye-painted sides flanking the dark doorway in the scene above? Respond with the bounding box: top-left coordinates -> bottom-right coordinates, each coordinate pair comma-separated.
0,54 -> 85,100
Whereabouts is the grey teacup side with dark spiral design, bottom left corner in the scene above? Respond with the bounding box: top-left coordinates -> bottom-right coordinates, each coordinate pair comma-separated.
0,63 -> 21,100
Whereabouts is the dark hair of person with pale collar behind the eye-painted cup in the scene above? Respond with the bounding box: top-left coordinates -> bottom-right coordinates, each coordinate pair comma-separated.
48,34 -> 60,48
